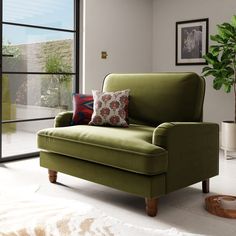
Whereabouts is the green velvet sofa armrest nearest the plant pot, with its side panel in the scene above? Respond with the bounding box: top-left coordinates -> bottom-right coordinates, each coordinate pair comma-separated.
152,122 -> 219,192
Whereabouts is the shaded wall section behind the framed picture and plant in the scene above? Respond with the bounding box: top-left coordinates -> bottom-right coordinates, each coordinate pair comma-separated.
153,0 -> 236,123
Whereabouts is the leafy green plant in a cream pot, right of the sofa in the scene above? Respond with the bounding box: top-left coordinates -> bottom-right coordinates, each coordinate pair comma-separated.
202,15 -> 236,159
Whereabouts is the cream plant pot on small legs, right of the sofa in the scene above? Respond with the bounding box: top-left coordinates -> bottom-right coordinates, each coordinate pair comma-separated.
221,121 -> 236,159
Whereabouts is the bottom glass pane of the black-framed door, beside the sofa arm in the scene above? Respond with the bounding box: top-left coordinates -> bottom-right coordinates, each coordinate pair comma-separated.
2,120 -> 54,158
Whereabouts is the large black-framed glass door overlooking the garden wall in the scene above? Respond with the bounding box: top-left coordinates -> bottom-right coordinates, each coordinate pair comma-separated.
0,0 -> 80,161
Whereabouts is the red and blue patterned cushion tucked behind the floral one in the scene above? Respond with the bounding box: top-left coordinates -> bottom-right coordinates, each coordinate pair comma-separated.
71,93 -> 93,125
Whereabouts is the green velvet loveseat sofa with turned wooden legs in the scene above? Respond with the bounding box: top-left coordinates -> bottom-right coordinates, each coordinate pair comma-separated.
38,73 -> 219,216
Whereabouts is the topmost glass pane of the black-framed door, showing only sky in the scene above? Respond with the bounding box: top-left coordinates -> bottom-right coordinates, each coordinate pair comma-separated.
3,0 -> 74,30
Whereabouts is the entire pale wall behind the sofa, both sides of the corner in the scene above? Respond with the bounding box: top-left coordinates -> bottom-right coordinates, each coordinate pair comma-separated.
81,0 -> 236,123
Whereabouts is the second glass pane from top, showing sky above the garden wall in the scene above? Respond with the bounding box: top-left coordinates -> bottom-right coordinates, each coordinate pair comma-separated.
3,25 -> 74,73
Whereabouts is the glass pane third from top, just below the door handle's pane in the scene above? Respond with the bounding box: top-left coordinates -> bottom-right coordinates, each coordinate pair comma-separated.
2,74 -> 74,121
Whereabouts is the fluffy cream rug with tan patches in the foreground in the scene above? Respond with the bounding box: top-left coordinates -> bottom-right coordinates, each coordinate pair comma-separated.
0,195 -> 202,236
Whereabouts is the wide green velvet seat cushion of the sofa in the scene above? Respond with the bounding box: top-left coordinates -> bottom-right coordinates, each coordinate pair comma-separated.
38,124 -> 167,175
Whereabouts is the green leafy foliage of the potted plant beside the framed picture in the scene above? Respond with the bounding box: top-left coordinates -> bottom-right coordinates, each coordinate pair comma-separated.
202,15 -> 236,93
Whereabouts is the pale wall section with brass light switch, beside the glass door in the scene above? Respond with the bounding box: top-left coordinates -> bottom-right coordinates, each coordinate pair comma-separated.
83,0 -> 153,93
